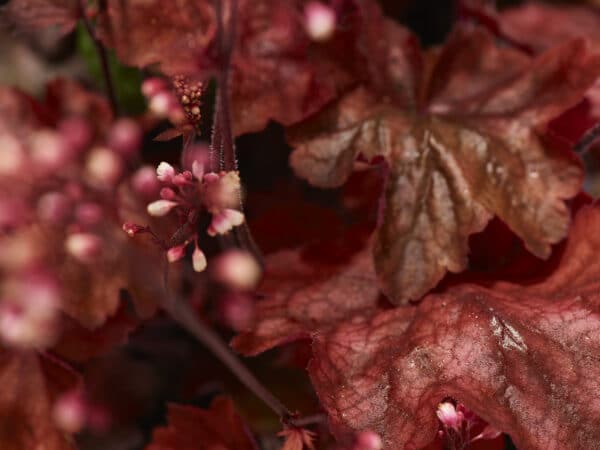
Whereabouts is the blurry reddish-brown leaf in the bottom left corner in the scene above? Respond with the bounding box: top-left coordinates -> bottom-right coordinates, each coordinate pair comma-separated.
0,349 -> 74,450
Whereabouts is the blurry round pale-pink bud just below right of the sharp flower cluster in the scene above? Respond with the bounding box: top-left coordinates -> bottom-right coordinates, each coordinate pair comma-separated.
211,250 -> 261,291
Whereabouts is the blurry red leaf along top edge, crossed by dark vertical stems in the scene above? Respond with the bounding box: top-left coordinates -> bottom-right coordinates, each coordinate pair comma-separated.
99,0 -> 383,135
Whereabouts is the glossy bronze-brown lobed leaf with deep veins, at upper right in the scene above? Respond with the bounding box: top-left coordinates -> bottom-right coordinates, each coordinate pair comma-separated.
289,28 -> 600,303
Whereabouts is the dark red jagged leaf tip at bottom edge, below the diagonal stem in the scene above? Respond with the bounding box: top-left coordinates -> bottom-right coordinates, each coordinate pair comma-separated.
146,397 -> 258,450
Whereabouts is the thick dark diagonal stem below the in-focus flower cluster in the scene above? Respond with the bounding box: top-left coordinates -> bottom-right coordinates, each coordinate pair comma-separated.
163,300 -> 292,422
